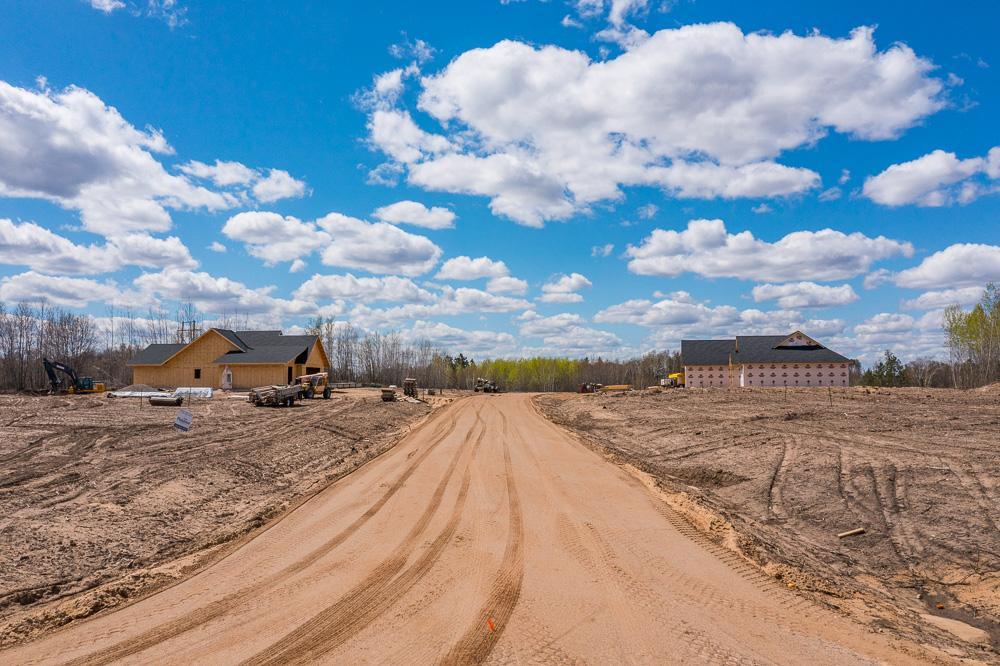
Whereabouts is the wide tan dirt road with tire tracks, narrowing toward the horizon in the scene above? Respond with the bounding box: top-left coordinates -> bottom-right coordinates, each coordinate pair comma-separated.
0,395 -> 929,664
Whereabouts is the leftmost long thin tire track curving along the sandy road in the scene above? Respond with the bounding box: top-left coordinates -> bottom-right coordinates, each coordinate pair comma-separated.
67,402 -> 464,666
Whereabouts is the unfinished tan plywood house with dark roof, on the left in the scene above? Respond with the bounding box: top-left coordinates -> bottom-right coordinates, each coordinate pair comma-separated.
129,328 -> 330,389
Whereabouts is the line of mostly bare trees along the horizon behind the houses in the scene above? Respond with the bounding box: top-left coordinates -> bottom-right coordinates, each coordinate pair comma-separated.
0,284 -> 1000,391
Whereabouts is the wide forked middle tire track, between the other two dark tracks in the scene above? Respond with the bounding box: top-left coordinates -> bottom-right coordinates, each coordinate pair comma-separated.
243,407 -> 486,666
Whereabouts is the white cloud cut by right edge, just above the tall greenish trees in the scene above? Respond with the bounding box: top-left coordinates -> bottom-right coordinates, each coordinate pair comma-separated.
893,243 -> 1000,289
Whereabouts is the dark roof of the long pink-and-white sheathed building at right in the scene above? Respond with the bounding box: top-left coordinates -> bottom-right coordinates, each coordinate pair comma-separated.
681,334 -> 850,365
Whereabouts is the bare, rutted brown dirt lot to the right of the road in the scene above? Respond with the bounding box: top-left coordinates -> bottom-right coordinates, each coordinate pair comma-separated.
536,387 -> 1000,660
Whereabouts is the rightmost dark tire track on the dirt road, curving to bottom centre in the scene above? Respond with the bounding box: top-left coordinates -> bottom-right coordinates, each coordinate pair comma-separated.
441,412 -> 524,664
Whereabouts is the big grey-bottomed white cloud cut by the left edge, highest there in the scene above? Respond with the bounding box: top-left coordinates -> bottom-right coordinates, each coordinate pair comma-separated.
0,81 -> 304,237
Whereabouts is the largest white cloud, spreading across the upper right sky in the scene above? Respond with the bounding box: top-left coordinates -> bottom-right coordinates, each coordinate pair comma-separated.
369,23 -> 944,226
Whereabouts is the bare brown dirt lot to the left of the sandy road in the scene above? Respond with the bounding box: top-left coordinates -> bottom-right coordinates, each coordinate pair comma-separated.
0,390 -> 430,647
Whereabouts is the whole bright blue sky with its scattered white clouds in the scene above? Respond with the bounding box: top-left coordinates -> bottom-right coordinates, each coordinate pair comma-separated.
0,0 -> 1000,360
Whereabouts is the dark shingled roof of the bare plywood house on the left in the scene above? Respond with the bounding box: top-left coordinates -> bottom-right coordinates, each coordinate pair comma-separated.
129,328 -> 318,365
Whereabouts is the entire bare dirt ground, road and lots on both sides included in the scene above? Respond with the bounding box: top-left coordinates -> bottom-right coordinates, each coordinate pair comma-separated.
0,377 -> 1000,664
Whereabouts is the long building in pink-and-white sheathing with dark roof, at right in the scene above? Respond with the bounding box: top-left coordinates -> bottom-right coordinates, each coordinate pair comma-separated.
681,331 -> 851,388
